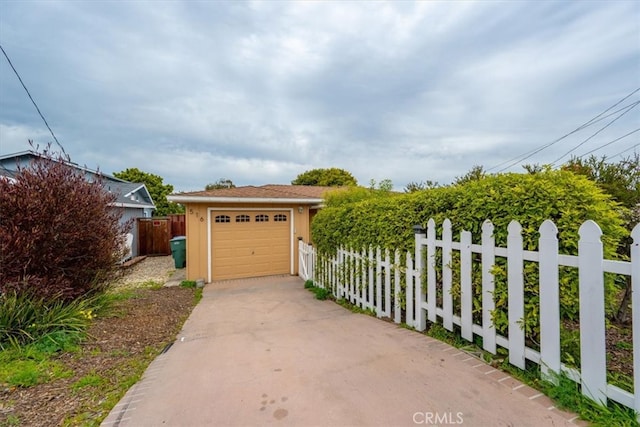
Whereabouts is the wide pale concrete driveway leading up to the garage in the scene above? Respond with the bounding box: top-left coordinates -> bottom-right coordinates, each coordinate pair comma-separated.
103,276 -> 582,426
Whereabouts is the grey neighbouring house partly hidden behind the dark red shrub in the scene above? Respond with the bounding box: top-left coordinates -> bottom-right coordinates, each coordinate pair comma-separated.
0,151 -> 156,257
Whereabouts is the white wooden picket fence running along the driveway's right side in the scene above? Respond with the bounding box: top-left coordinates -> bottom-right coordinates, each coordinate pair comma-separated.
299,219 -> 640,413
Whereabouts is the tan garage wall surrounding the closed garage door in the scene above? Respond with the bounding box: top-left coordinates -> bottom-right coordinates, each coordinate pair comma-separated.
185,203 -> 310,281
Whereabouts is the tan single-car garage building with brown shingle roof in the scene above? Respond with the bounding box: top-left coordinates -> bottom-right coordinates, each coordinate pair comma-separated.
168,185 -> 335,282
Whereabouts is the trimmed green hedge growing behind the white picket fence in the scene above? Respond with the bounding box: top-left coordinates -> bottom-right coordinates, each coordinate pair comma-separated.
311,170 -> 628,340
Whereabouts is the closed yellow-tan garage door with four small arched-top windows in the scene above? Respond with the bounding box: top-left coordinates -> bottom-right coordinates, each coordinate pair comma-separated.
211,210 -> 291,280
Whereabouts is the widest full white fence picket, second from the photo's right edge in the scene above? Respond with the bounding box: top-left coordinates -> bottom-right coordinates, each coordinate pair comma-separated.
578,220 -> 607,404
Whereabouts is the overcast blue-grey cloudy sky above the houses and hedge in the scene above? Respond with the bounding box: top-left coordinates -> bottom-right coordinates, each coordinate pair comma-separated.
0,0 -> 640,191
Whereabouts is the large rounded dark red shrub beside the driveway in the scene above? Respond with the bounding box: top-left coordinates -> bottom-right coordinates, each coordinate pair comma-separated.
0,149 -> 128,300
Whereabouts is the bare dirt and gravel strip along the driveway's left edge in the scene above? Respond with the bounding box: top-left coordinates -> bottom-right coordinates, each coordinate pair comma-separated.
0,257 -> 195,426
